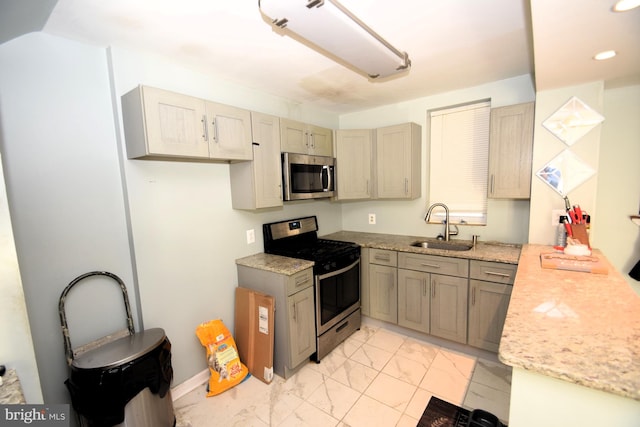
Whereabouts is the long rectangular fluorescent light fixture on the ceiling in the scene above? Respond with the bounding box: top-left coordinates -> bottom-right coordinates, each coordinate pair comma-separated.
258,0 -> 411,79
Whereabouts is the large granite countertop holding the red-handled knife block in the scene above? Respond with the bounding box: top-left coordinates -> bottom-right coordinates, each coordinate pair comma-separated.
498,245 -> 640,400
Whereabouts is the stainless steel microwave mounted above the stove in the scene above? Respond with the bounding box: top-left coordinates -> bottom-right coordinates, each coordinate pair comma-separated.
282,153 -> 335,200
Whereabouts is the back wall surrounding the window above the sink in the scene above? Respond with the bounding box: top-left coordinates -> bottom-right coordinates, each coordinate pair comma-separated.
340,75 -> 535,243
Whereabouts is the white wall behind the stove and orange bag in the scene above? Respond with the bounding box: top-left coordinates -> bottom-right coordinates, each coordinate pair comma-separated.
110,48 -> 342,384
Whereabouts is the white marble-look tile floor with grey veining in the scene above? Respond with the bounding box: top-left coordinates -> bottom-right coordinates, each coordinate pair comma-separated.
174,324 -> 511,427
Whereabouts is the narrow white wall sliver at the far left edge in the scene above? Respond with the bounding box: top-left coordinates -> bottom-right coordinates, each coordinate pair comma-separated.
0,155 -> 42,403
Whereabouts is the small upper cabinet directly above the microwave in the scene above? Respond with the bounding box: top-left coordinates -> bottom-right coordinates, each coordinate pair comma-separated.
280,119 -> 333,157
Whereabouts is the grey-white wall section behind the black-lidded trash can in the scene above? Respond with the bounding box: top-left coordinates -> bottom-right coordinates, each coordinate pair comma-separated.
0,33 -> 135,403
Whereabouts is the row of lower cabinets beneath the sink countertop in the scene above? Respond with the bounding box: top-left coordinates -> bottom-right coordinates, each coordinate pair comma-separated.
361,248 -> 518,352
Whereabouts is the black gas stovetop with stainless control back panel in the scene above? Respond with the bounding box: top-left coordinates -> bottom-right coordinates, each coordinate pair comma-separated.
262,216 -> 360,272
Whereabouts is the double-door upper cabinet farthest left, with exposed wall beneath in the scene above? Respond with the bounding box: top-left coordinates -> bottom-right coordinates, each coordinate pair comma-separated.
122,86 -> 253,161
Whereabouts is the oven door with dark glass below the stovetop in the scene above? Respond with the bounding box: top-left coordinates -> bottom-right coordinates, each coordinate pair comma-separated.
316,259 -> 360,336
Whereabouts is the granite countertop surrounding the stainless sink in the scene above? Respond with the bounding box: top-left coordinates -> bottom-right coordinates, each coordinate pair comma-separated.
322,231 -> 521,264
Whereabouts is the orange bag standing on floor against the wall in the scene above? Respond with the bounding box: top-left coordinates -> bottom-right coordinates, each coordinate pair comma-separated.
196,319 -> 249,397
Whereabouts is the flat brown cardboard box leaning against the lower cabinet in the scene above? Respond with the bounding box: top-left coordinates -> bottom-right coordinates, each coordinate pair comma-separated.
234,287 -> 276,384
